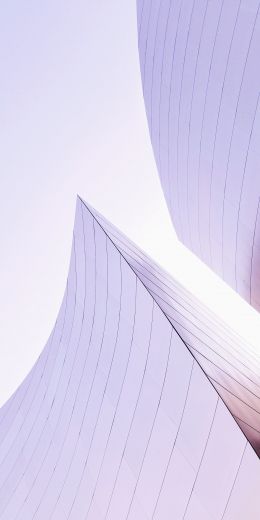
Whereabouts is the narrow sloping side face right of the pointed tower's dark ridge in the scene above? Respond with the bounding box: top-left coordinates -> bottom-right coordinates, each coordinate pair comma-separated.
89,203 -> 260,455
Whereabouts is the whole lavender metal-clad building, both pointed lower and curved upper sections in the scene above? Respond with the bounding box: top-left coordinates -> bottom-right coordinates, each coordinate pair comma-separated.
0,0 -> 260,520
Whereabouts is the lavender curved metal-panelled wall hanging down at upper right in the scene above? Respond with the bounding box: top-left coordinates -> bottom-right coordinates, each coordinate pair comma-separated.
137,0 -> 260,309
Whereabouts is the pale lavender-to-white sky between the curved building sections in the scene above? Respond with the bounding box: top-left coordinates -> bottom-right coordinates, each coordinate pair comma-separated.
0,0 -> 260,404
